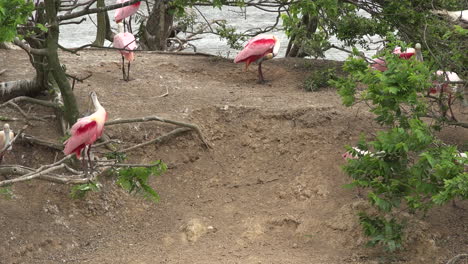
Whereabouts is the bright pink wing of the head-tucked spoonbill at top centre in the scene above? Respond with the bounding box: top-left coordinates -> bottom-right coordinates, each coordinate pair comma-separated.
234,36 -> 276,63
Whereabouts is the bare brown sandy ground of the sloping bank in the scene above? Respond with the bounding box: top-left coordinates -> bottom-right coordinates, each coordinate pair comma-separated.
0,50 -> 468,264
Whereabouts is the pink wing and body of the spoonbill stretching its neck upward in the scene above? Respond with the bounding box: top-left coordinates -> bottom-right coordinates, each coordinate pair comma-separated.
63,117 -> 98,158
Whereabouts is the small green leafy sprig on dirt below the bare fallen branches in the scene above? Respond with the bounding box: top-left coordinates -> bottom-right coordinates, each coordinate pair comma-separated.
116,161 -> 167,202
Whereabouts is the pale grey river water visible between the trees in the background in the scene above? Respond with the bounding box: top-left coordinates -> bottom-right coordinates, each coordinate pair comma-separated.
60,0 -> 375,60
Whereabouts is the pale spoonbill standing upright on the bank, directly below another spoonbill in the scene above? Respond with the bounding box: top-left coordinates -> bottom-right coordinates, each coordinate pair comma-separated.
114,23 -> 136,81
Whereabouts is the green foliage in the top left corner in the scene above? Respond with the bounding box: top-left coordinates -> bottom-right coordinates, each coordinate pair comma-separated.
0,0 -> 34,42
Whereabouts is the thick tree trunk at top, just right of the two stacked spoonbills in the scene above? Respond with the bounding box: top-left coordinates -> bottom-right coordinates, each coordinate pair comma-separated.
140,0 -> 174,50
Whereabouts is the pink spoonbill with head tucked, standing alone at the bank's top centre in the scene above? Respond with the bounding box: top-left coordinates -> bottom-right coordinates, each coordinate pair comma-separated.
234,35 -> 280,83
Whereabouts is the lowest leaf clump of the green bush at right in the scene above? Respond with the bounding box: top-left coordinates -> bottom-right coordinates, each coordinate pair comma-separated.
359,213 -> 403,252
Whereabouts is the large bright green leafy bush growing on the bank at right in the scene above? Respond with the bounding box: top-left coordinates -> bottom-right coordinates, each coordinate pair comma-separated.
331,41 -> 468,251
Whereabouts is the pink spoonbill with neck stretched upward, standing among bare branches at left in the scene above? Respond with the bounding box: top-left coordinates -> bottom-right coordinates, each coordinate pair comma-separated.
63,92 -> 107,172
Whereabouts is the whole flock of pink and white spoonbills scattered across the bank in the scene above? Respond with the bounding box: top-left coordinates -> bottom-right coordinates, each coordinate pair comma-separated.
0,0 -> 461,169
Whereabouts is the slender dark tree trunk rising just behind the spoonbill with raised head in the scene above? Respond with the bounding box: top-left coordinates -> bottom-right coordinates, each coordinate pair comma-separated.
45,0 -> 79,125
